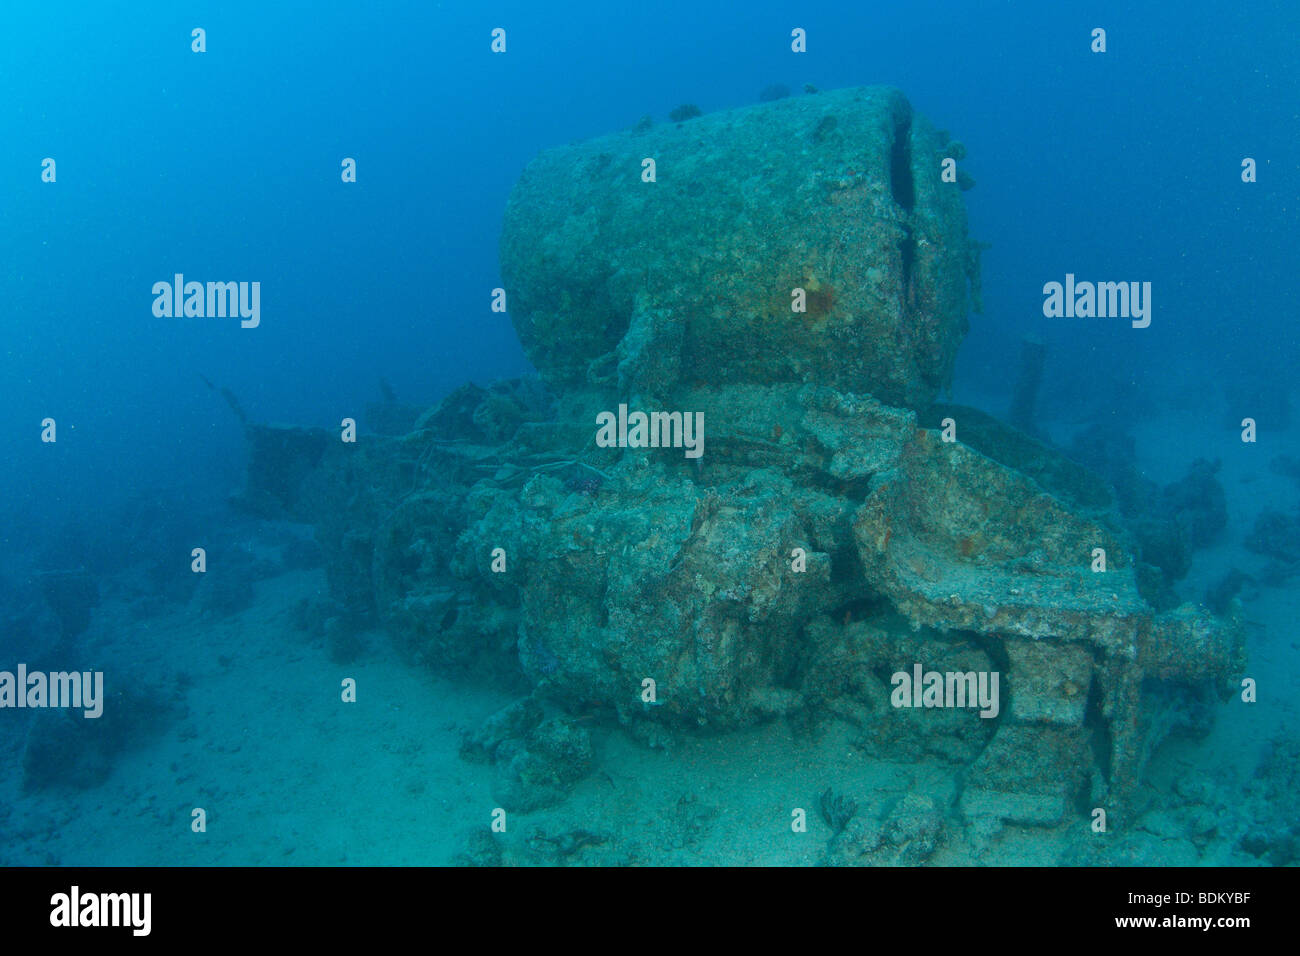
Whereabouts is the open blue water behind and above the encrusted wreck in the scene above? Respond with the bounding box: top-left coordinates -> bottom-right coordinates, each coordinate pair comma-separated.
0,0 -> 1300,864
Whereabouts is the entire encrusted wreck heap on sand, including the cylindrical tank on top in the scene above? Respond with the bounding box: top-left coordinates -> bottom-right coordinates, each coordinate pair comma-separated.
231,87 -> 1242,853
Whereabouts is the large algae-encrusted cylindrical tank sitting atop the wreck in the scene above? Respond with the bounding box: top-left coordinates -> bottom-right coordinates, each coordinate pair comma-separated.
501,87 -> 976,406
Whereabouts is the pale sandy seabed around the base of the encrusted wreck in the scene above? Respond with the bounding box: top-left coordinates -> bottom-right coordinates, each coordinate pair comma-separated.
0,412 -> 1300,866
